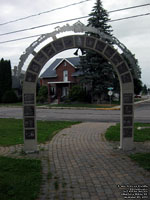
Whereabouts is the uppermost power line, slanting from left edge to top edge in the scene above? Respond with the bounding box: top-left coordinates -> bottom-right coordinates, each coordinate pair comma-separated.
0,0 -> 91,26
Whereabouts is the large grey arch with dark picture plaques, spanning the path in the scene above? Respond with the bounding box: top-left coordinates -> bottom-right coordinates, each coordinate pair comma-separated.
23,35 -> 134,152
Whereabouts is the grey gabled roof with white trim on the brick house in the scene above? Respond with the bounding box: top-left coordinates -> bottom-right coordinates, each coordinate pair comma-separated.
40,57 -> 80,78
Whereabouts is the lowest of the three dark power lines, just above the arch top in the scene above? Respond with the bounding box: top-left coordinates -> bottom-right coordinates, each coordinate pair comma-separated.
0,13 -> 150,44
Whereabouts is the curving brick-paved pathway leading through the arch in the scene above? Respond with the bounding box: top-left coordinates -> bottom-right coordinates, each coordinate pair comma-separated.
1,123 -> 150,200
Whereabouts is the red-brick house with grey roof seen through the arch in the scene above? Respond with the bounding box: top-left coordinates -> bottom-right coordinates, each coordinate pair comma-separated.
40,57 -> 82,103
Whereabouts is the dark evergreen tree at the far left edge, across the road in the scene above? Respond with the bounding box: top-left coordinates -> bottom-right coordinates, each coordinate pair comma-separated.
0,58 -> 12,102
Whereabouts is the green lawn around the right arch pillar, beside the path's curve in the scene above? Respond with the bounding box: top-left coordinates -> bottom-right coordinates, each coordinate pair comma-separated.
105,123 -> 150,142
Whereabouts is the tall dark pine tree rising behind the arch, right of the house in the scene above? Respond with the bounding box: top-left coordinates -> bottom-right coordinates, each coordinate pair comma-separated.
80,0 -> 119,101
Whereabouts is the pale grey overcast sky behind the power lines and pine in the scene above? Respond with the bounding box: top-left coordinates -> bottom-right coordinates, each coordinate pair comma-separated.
0,0 -> 150,87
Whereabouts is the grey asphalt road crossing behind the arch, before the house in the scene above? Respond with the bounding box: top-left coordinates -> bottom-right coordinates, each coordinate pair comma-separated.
0,102 -> 150,123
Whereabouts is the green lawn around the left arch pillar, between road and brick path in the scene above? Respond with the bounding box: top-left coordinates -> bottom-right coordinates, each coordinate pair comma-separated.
0,119 -> 79,146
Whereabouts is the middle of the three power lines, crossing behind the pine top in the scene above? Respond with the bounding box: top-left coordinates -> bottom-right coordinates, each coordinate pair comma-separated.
0,0 -> 150,36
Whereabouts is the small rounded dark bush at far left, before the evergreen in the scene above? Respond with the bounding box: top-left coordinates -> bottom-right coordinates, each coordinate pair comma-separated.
2,90 -> 18,103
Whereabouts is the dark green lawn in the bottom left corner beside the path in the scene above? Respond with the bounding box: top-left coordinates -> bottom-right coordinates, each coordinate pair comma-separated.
0,156 -> 42,200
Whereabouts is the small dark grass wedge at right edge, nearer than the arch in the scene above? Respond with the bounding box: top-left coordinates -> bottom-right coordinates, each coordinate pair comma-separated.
129,153 -> 150,171
